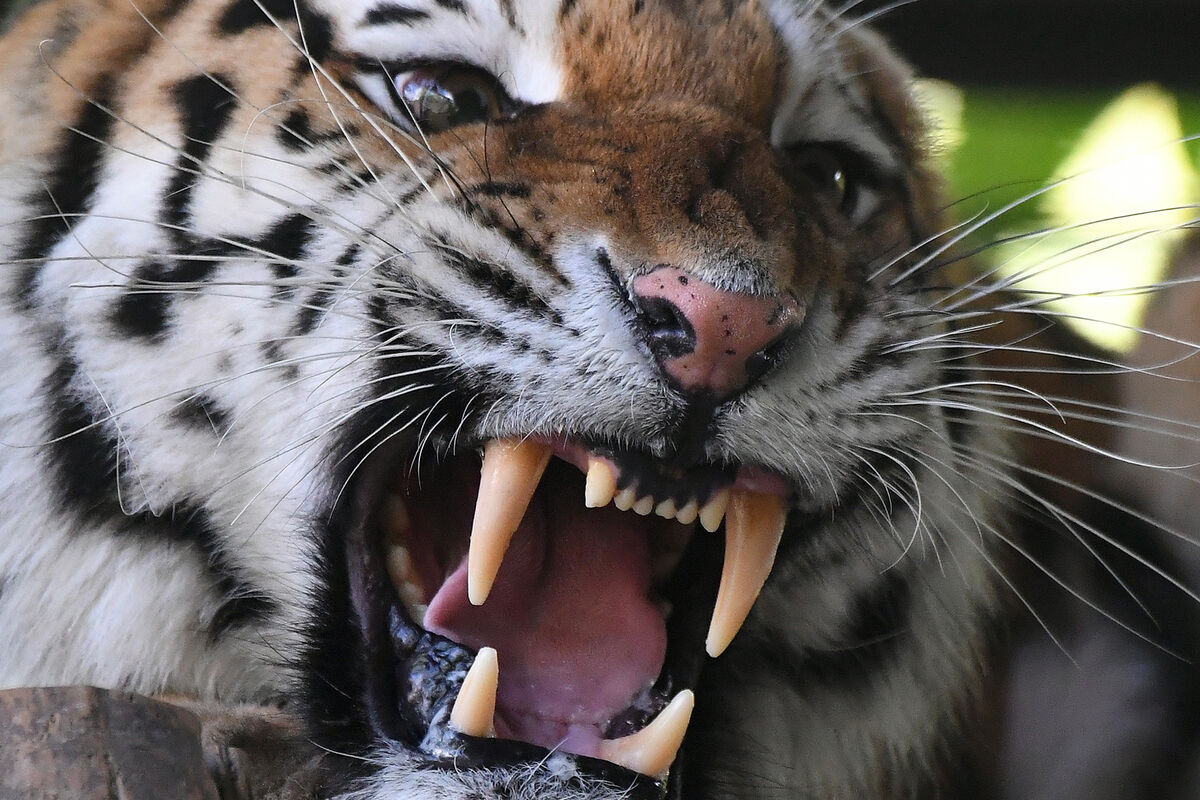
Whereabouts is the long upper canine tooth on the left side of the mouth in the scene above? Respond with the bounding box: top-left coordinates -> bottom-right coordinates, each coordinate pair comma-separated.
467,439 -> 551,606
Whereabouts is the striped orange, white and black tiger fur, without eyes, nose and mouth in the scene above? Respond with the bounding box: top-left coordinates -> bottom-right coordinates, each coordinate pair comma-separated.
0,0 -> 1190,800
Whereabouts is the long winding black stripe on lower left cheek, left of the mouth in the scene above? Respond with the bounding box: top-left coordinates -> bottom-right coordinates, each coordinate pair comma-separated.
46,342 -> 276,639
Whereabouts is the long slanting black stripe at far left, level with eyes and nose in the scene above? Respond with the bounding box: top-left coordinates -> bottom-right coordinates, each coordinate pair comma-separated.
16,76 -> 115,311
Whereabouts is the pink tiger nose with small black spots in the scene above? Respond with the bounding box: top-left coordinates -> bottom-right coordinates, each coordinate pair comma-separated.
634,266 -> 804,399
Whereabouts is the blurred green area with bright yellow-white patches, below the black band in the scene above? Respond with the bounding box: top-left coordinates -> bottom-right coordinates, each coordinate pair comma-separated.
923,82 -> 1200,350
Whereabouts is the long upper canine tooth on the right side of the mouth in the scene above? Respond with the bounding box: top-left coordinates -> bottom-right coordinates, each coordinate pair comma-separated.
704,492 -> 787,658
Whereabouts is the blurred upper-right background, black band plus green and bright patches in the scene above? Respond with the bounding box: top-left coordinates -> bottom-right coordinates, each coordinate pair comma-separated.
873,0 -> 1200,349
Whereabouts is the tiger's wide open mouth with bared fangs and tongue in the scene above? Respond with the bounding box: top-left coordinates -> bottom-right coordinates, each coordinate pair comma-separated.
349,438 -> 788,788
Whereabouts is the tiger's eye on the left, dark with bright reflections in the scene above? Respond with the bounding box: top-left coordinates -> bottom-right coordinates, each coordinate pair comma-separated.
397,66 -> 505,133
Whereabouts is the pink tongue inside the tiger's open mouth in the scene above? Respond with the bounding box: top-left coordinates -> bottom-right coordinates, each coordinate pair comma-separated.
425,485 -> 667,756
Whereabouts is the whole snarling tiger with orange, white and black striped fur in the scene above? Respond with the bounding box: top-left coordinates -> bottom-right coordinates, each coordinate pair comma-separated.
0,0 -> 1190,800
